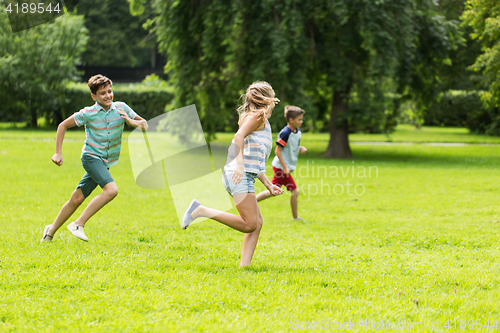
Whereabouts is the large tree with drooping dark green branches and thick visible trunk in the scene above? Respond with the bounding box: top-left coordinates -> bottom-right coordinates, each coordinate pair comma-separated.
131,0 -> 453,158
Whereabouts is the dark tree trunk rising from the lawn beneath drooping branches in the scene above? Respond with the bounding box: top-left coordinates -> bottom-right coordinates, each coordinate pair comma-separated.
325,89 -> 352,159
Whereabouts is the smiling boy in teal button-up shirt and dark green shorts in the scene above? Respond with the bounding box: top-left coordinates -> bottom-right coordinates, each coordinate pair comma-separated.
42,75 -> 148,242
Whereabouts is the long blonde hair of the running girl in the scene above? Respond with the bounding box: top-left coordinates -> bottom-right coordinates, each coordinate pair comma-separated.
238,81 -> 280,126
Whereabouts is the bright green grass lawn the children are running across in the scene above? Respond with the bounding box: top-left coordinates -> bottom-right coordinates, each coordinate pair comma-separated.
0,127 -> 500,332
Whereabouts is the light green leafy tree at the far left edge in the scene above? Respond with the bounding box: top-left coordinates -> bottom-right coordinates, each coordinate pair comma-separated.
0,9 -> 87,127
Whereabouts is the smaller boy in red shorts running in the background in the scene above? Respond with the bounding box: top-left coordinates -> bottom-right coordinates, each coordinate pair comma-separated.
257,105 -> 307,222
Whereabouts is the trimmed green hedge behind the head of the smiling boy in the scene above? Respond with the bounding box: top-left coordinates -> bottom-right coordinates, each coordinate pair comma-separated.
61,81 -> 173,120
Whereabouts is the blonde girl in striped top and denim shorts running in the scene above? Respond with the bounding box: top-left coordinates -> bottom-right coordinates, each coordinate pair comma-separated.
182,81 -> 283,267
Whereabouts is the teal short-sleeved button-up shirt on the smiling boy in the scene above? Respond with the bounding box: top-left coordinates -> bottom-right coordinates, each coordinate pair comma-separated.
73,102 -> 137,168
